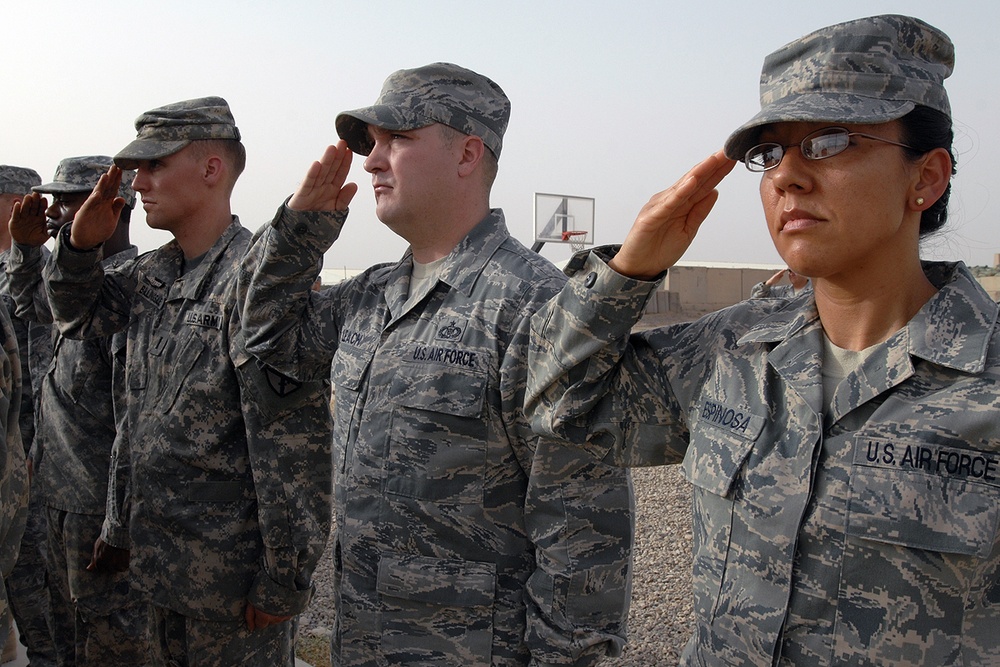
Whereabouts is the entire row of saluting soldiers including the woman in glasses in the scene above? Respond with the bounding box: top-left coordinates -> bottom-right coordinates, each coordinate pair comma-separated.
0,10 -> 988,667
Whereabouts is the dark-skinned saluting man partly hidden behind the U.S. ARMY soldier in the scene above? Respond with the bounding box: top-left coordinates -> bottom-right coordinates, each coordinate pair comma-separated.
7,155 -> 149,667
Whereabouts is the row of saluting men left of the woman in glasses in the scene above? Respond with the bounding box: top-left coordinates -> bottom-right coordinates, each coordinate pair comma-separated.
0,58 -> 632,667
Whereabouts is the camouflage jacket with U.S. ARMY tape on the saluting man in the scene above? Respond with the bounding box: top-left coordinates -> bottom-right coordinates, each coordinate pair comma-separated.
46,218 -> 330,664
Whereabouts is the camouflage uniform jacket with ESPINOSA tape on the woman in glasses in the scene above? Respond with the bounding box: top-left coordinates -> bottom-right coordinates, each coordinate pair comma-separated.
527,254 -> 1000,667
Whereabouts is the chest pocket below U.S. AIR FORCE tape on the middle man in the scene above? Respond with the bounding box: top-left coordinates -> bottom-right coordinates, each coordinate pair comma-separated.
386,364 -> 489,503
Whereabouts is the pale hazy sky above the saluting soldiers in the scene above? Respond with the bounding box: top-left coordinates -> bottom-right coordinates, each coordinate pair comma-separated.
0,0 -> 1000,268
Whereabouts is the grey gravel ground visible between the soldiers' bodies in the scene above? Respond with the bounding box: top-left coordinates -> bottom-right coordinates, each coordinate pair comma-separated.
299,315 -> 692,667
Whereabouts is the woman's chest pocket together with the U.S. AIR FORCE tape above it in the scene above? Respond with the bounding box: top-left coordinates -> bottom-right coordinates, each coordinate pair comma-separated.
834,439 -> 1000,665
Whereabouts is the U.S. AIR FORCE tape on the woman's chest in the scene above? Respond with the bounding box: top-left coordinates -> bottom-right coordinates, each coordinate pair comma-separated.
854,438 -> 1000,483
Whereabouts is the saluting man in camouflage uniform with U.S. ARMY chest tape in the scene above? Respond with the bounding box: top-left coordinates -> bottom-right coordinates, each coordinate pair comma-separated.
13,97 -> 330,667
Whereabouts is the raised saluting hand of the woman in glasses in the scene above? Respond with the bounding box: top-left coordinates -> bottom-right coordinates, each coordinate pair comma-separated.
609,151 -> 736,279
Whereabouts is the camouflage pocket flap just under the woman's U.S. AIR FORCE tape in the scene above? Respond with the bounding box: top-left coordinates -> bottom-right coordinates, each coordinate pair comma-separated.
847,466 -> 1000,558
